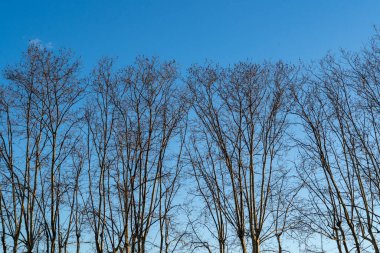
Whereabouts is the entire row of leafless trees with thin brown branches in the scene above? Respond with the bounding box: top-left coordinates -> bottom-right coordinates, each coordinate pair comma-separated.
0,34 -> 380,253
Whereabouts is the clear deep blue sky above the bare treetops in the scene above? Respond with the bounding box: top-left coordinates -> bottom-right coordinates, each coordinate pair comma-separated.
0,0 -> 380,68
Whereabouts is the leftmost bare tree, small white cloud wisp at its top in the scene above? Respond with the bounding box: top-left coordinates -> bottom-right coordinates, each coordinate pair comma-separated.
0,44 -> 83,252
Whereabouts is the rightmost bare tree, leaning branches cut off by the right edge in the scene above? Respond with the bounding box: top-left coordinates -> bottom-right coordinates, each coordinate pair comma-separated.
295,34 -> 379,252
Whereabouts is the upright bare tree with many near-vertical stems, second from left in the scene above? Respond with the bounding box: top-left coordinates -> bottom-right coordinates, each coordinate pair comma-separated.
87,58 -> 187,252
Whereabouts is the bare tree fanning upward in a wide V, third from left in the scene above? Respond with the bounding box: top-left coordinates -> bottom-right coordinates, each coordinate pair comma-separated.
188,62 -> 293,252
